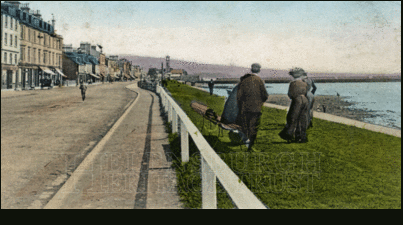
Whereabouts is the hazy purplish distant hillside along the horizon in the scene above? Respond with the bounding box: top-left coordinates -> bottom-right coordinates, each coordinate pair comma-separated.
120,55 -> 401,79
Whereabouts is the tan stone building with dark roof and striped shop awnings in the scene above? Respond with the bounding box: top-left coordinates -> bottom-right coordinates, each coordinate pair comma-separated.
2,2 -> 65,89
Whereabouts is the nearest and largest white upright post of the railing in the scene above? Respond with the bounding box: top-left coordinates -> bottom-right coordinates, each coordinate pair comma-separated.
201,156 -> 217,209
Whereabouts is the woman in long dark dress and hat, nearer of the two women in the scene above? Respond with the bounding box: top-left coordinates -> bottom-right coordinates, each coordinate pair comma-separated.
279,67 -> 309,143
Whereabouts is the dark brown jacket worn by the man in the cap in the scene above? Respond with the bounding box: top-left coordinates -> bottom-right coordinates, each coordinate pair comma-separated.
237,74 -> 269,114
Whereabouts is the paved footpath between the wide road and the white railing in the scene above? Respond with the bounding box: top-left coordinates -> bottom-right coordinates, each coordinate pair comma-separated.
45,84 -> 181,209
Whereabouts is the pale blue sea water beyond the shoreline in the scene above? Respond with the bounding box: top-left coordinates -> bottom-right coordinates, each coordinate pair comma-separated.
204,82 -> 402,129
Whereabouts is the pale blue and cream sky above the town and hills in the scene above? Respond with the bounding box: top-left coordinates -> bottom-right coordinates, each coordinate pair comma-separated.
7,1 -> 401,73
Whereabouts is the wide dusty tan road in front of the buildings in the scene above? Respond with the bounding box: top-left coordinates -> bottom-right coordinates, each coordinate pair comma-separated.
1,82 -> 137,209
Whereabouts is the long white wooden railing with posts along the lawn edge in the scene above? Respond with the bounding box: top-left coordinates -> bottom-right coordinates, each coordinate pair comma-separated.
156,86 -> 267,209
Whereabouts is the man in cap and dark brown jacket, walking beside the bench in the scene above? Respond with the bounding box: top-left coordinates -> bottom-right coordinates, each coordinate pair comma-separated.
236,63 -> 269,150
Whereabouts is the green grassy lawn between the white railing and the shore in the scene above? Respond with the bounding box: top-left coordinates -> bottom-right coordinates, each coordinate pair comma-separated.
162,81 -> 401,209
